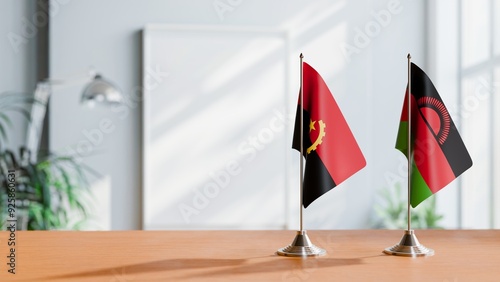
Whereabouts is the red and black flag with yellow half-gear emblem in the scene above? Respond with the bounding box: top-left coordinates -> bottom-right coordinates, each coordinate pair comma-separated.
292,63 -> 366,208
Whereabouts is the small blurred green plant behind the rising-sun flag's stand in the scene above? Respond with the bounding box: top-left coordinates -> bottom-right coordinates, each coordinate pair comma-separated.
373,183 -> 443,229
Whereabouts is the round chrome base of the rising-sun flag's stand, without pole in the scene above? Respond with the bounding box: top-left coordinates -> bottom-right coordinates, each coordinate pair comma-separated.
384,230 -> 434,257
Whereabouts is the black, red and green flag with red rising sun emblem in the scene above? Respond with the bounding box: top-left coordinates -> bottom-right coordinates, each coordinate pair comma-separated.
396,63 -> 472,207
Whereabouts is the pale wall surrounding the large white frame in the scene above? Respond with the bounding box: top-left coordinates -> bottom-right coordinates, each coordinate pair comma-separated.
50,0 -> 426,229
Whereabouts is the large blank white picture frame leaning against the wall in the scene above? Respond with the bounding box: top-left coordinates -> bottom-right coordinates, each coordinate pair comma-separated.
142,25 -> 292,230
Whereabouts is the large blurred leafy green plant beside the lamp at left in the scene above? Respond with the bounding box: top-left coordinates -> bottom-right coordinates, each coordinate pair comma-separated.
0,94 -> 93,230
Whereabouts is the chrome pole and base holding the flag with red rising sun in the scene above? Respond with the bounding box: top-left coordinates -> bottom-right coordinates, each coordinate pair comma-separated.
384,54 -> 434,257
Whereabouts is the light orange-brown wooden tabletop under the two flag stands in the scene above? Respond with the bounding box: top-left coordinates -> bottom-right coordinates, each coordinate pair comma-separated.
0,230 -> 500,282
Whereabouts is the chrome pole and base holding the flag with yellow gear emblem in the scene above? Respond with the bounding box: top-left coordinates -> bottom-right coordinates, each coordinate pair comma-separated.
276,53 -> 326,257
